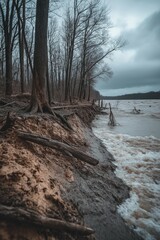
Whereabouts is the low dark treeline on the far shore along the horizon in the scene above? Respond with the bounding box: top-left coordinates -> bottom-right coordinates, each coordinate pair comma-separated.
101,91 -> 160,100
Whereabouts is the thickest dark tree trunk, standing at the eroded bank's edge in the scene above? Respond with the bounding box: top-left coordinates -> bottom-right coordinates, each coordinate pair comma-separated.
29,0 -> 52,113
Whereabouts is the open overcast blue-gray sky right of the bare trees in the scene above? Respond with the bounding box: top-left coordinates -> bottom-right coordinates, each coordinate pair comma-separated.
96,0 -> 160,96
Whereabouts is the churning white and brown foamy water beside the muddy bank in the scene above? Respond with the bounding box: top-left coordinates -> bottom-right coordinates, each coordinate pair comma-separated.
93,124 -> 160,240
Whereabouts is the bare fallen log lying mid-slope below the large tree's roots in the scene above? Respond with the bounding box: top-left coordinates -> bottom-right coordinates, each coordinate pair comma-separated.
18,132 -> 99,166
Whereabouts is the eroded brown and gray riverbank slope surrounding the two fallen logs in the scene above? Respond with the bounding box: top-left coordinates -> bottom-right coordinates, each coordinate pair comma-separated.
0,101 -> 141,240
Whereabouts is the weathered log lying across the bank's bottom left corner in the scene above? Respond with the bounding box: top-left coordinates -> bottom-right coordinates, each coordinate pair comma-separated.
0,204 -> 94,235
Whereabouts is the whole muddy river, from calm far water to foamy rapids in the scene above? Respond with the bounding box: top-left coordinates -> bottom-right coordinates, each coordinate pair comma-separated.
92,100 -> 160,240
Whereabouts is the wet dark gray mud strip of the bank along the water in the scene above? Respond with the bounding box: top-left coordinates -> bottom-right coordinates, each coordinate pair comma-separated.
62,124 -> 142,240
